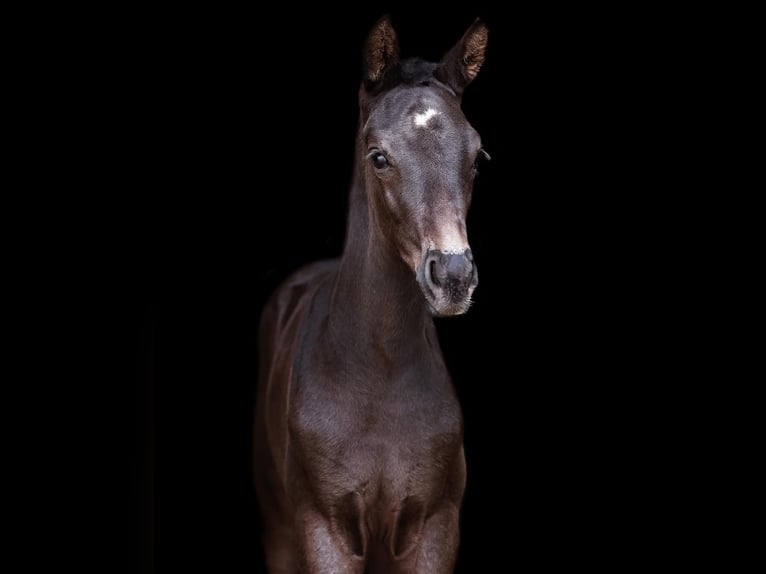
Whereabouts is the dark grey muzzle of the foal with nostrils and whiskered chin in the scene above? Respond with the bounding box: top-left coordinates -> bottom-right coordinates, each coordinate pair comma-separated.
417,249 -> 479,317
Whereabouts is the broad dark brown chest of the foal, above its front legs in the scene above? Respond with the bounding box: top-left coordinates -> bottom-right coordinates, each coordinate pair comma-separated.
290,374 -> 462,498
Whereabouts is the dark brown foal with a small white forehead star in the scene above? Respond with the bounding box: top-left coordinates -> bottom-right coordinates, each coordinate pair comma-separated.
253,16 -> 489,574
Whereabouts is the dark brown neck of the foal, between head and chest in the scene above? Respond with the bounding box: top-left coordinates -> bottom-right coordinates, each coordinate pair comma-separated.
329,146 -> 433,363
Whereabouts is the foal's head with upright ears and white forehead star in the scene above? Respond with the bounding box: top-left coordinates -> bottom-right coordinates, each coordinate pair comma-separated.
358,17 -> 489,316
